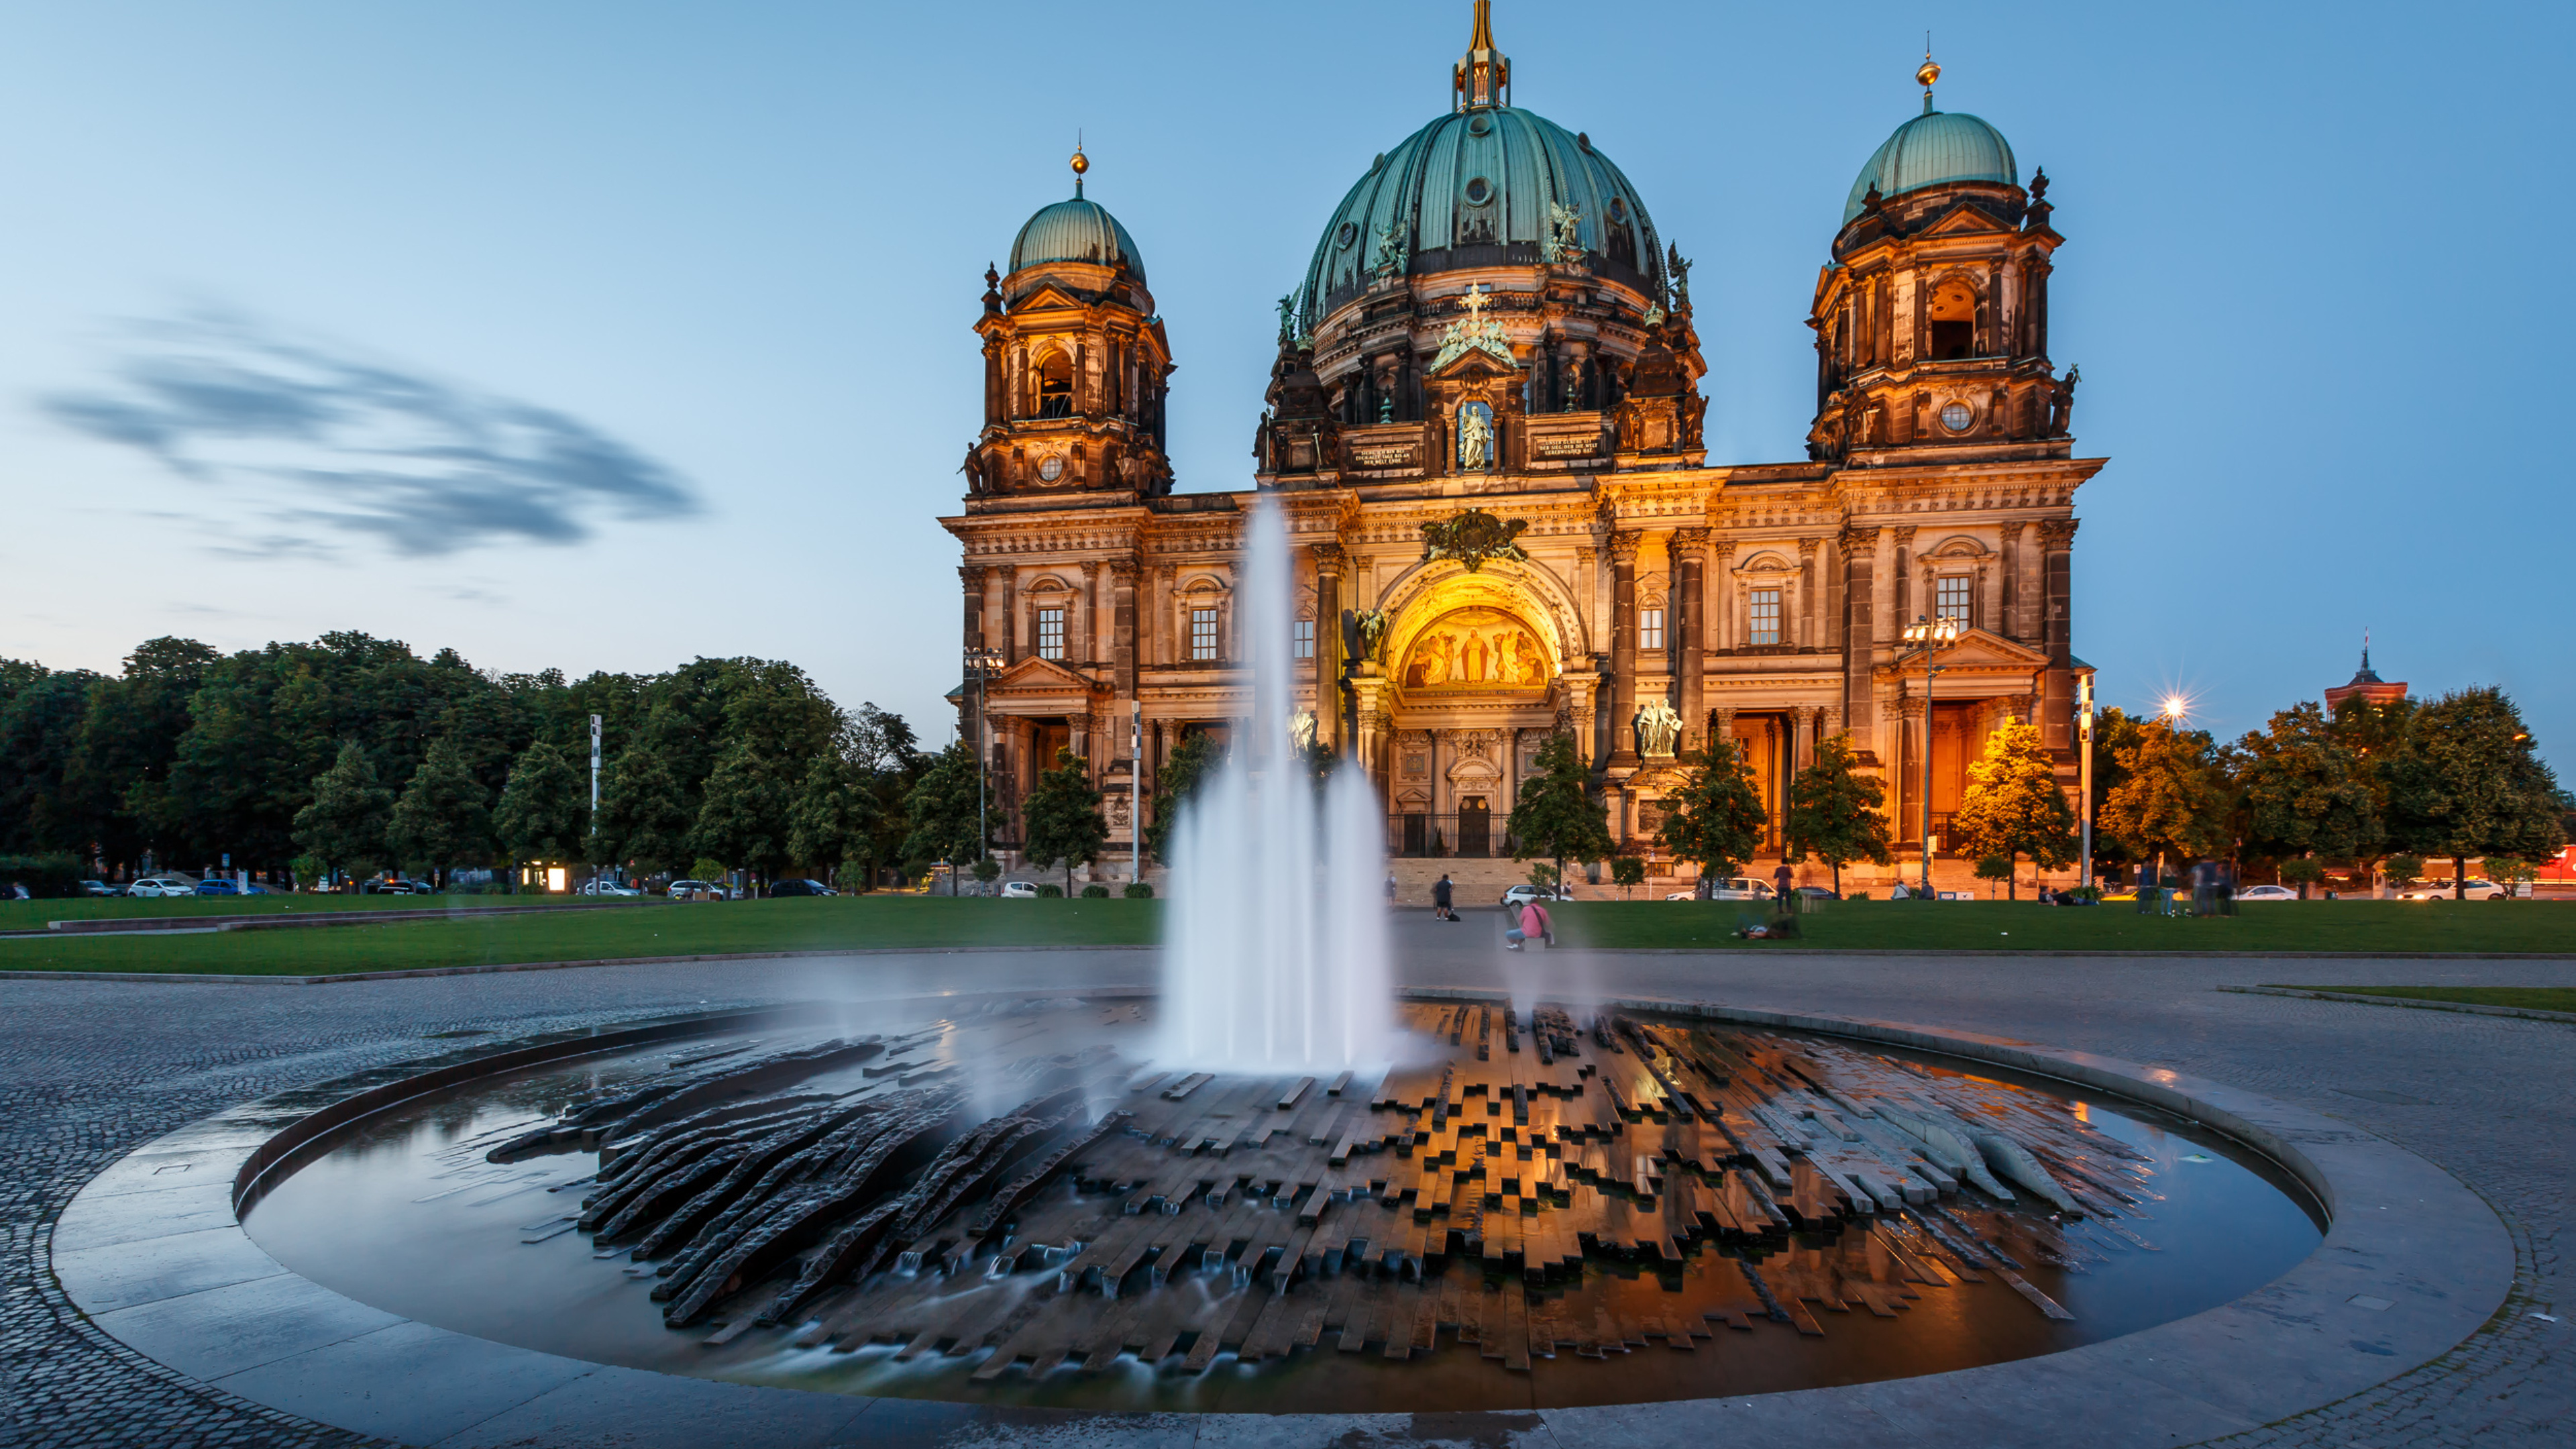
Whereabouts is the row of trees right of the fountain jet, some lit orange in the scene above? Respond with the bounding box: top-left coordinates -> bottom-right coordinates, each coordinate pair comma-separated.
1509,688 -> 2576,895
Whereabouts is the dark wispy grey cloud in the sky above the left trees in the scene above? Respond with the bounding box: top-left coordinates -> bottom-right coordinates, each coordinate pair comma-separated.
41,317 -> 698,557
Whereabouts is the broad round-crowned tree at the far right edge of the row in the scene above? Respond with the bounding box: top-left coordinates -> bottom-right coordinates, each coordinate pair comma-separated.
2388,686 -> 2566,898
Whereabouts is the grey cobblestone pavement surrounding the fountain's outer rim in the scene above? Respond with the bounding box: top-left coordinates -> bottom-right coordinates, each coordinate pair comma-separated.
0,938 -> 2576,1446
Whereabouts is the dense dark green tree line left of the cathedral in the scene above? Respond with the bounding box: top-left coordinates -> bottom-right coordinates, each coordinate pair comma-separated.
0,632 -> 1004,884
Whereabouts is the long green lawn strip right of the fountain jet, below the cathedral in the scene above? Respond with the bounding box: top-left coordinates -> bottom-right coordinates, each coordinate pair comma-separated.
1556,900 -> 2576,954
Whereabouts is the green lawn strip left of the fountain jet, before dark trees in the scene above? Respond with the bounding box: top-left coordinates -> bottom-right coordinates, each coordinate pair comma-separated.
0,895 -> 1162,977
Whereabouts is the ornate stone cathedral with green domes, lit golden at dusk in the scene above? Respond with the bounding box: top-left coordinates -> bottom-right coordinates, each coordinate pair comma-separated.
941,0 -> 2107,874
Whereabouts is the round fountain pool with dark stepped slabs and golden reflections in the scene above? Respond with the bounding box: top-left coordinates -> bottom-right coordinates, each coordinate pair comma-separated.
242,998 -> 2321,1413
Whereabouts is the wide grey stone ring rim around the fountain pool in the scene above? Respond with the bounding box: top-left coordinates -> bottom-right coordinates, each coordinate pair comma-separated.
49,987 -> 2514,1449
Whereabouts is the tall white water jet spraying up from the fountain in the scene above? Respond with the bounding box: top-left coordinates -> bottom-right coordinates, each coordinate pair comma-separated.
1162,492 -> 1393,1073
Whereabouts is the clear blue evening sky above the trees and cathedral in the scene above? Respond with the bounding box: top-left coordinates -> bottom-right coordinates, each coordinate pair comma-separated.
0,0 -> 2576,761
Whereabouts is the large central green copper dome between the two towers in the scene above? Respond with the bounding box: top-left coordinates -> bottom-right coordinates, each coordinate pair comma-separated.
1306,106 -> 1664,322
